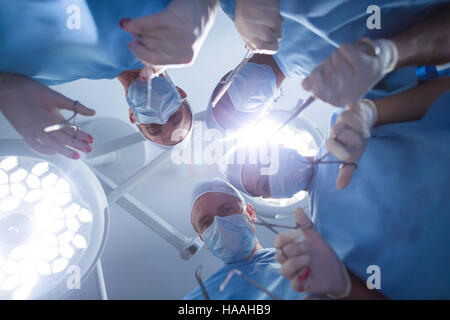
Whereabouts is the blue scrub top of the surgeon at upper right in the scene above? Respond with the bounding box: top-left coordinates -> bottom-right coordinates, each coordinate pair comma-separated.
221,0 -> 450,99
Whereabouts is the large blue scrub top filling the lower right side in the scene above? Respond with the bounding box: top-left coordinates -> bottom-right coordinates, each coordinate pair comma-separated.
310,92 -> 450,299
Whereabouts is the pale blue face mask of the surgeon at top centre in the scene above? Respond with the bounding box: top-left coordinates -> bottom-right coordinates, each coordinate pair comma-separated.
225,62 -> 280,112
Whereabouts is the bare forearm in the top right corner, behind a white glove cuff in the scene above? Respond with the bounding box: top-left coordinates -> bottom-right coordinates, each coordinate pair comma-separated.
392,5 -> 450,68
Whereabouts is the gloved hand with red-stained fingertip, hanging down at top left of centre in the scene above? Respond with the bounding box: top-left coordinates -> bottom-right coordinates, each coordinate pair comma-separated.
121,0 -> 218,77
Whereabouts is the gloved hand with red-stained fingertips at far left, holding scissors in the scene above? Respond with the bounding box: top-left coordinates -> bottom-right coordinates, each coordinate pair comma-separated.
0,74 -> 95,159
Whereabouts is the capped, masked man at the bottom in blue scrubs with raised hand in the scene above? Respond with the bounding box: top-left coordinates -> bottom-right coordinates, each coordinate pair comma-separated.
184,179 -> 382,300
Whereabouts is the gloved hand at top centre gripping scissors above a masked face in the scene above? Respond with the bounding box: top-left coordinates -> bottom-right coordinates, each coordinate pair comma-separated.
234,0 -> 283,54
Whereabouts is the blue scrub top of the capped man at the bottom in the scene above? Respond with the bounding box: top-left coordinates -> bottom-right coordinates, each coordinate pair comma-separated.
183,248 -> 306,300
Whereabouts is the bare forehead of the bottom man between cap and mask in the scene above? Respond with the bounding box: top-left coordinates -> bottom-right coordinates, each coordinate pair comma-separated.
191,192 -> 241,222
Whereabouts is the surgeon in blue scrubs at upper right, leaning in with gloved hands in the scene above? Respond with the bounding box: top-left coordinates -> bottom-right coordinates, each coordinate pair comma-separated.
206,0 -> 450,130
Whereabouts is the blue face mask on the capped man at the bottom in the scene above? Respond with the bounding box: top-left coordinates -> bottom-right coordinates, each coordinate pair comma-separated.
202,213 -> 256,263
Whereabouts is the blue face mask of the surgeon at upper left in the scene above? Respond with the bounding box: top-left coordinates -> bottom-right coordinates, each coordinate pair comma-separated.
127,77 -> 183,124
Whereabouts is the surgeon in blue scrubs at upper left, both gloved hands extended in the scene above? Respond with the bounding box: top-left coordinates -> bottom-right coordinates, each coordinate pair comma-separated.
0,0 -> 218,159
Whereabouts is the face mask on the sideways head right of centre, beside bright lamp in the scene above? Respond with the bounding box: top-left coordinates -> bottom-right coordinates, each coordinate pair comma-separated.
269,148 -> 313,199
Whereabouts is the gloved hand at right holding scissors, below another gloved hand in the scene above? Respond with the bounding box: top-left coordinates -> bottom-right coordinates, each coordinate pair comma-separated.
325,99 -> 377,189
